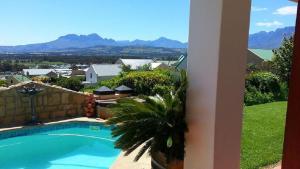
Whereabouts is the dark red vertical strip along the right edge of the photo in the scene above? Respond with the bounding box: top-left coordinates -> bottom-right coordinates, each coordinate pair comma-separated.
282,5 -> 300,169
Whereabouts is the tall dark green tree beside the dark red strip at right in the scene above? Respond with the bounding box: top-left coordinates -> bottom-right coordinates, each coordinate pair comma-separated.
272,36 -> 294,82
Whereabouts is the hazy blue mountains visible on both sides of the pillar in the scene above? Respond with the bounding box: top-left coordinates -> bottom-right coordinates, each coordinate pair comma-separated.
0,27 -> 295,53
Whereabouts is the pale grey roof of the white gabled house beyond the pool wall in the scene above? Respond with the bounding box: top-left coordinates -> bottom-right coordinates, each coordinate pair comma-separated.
91,64 -> 122,76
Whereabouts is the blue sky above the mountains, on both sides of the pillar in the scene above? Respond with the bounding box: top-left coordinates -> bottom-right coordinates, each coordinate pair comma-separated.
0,0 -> 295,45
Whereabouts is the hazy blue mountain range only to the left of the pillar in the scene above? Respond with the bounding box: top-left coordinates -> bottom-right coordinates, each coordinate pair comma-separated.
0,33 -> 187,53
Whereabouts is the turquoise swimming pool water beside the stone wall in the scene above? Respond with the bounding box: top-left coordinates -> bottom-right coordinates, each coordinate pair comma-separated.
0,122 -> 120,169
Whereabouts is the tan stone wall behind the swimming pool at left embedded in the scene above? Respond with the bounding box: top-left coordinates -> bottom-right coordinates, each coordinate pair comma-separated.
0,82 -> 86,127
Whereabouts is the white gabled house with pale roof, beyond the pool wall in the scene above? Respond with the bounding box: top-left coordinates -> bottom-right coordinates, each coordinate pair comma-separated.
84,64 -> 122,84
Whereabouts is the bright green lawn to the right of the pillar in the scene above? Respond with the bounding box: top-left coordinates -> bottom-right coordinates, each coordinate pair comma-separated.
241,102 -> 287,169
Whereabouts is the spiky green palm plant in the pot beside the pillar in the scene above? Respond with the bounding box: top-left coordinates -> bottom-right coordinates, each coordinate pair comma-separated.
107,71 -> 187,168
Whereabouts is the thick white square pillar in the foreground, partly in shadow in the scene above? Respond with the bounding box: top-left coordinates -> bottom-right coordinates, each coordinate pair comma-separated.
185,0 -> 251,169
